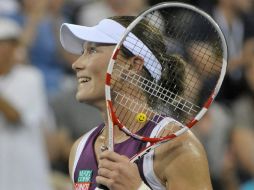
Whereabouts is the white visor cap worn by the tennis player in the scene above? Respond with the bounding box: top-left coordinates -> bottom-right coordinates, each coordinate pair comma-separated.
60,19 -> 162,81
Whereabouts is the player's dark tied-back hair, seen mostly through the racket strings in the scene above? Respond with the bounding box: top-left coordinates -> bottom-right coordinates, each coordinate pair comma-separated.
109,16 -> 185,108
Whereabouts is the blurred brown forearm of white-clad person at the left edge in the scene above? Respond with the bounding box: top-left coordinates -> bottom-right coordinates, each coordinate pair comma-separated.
0,96 -> 20,123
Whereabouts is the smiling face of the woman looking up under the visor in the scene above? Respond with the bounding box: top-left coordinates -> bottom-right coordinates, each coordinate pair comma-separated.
72,42 -> 115,108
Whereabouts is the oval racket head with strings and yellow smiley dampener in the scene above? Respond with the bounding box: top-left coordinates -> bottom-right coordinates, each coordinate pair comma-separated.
105,3 -> 227,142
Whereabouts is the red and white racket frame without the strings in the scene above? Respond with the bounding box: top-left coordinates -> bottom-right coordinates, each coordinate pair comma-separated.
105,2 -> 227,150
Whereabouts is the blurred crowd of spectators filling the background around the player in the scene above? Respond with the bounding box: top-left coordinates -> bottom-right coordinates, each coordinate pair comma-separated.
0,0 -> 254,190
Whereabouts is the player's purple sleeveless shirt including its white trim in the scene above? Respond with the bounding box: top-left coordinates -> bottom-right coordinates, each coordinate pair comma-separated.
71,119 -> 171,190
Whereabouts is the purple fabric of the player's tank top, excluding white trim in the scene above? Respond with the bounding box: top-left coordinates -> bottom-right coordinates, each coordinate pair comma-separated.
74,121 -> 155,190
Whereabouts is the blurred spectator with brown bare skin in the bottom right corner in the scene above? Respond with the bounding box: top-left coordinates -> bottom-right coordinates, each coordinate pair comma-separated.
221,126 -> 254,190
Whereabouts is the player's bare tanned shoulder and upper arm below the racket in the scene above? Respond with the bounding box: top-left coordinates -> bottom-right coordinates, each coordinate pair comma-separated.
154,131 -> 212,190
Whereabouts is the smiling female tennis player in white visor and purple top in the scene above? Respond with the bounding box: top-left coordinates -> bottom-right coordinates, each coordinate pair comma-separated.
60,16 -> 212,190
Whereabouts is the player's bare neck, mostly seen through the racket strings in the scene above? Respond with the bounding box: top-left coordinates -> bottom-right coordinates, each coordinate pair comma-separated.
97,84 -> 155,143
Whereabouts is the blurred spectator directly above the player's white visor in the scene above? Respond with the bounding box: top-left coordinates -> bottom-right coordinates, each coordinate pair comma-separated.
77,0 -> 148,26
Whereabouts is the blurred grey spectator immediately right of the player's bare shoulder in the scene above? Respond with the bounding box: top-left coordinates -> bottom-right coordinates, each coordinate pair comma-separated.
193,103 -> 233,190
